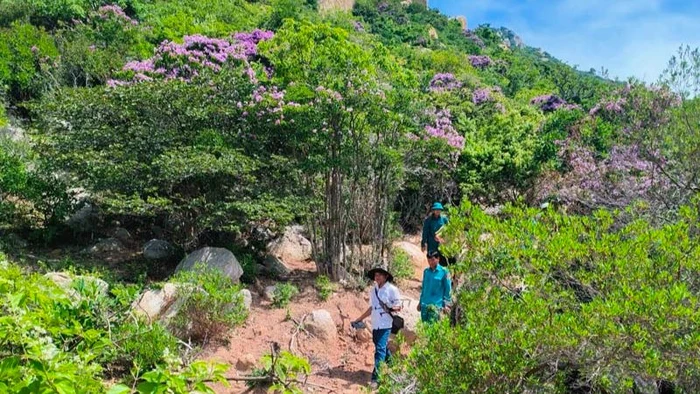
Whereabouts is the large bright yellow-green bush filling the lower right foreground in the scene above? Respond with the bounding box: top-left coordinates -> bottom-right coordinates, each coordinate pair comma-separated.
392,203 -> 700,393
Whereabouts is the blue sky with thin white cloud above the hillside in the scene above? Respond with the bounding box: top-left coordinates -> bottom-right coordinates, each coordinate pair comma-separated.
429,0 -> 700,82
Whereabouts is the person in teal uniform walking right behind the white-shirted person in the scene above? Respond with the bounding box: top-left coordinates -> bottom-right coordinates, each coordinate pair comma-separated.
418,251 -> 452,322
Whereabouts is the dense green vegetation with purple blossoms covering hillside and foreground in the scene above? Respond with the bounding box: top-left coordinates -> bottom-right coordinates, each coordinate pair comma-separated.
0,0 -> 700,392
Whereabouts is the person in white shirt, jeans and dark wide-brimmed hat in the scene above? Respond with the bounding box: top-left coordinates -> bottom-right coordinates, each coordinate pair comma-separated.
354,268 -> 401,387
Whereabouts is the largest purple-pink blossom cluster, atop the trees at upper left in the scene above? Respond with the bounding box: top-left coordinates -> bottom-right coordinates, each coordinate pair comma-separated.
108,30 -> 274,86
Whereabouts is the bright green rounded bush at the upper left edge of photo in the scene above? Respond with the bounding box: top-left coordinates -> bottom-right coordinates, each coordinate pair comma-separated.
0,23 -> 58,102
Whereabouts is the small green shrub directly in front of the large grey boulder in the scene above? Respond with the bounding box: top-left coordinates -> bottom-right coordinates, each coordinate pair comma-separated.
173,264 -> 248,344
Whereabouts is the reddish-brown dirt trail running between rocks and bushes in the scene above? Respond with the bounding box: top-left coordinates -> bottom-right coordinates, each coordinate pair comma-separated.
202,242 -> 420,394
